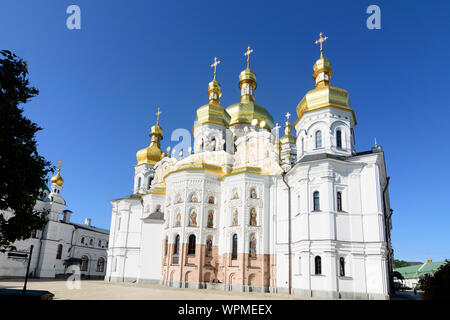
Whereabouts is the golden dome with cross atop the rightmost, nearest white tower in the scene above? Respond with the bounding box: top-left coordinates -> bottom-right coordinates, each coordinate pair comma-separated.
296,34 -> 356,125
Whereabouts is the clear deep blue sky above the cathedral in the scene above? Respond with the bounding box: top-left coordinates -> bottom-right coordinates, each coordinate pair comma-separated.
0,0 -> 450,261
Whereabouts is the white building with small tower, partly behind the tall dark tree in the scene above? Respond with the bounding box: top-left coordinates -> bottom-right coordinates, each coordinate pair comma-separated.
0,184 -> 109,279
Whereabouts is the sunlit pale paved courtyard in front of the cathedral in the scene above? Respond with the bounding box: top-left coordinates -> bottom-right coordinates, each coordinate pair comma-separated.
0,279 -> 312,300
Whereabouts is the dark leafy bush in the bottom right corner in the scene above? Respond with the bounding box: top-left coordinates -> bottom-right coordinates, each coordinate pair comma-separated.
419,260 -> 450,300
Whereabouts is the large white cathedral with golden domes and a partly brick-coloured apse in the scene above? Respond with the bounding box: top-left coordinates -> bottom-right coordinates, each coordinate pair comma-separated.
105,33 -> 393,299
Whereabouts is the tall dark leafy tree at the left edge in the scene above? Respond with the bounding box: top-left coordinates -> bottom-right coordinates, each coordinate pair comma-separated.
0,50 -> 54,250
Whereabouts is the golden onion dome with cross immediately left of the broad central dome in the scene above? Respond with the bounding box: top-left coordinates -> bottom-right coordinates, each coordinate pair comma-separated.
195,58 -> 230,128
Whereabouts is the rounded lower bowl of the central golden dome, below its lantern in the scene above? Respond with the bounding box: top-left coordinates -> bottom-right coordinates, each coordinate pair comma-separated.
226,101 -> 273,130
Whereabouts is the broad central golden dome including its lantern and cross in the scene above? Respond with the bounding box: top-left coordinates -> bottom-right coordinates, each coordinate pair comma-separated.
226,47 -> 273,130
